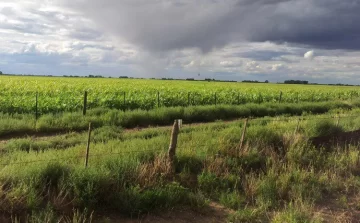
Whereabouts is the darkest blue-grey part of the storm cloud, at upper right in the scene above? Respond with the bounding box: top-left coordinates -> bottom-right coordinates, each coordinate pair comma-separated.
250,0 -> 360,50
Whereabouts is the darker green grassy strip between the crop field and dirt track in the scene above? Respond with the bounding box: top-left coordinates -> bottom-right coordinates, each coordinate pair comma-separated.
0,101 -> 360,138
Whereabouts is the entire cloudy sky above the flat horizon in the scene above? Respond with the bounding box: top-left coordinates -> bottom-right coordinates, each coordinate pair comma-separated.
0,0 -> 360,84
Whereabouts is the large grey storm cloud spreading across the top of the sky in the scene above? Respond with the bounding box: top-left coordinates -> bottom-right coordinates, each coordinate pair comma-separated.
54,0 -> 360,52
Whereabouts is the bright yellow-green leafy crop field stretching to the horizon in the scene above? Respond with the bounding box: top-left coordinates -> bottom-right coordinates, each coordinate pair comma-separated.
0,76 -> 360,113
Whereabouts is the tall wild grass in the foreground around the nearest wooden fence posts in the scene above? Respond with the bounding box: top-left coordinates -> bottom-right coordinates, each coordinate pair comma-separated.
0,111 -> 360,222
